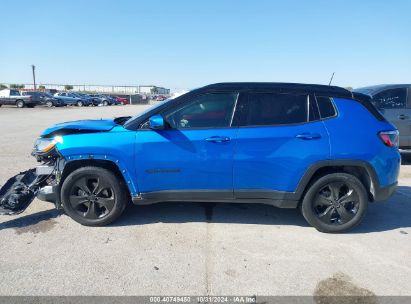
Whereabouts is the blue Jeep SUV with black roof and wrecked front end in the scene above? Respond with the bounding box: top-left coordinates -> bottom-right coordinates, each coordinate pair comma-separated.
2,83 -> 400,232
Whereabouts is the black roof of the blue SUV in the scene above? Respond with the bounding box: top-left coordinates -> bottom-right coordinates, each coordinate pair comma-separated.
200,82 -> 353,98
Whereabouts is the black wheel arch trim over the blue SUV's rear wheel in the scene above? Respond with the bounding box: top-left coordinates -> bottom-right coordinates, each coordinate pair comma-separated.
302,166 -> 374,201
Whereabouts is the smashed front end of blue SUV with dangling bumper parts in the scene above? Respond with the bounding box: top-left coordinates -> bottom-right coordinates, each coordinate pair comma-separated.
0,136 -> 65,215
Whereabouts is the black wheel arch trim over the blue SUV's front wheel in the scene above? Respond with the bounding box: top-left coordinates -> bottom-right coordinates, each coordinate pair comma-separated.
60,159 -> 131,199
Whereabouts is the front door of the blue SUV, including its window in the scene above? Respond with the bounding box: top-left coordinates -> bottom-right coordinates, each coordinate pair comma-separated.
136,92 -> 238,200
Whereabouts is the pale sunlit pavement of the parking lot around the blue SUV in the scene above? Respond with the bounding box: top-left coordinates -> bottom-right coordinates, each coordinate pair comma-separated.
0,105 -> 411,296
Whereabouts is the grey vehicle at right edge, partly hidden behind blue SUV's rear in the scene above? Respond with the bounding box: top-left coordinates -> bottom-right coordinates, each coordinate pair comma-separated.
354,84 -> 411,149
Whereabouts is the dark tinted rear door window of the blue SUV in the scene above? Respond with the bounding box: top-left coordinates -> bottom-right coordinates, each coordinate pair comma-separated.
246,93 -> 308,126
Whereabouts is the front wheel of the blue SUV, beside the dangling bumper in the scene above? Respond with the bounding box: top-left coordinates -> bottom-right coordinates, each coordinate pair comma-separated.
61,167 -> 128,226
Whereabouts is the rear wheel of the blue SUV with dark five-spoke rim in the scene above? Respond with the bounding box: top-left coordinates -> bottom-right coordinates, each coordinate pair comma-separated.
301,173 -> 368,233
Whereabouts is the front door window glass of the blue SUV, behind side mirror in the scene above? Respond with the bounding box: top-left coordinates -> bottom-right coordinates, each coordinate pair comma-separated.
163,93 -> 238,129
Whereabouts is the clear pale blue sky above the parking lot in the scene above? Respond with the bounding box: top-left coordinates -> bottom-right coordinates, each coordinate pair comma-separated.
0,0 -> 411,90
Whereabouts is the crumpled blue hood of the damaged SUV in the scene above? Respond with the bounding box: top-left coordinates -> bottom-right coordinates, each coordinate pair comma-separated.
41,119 -> 117,137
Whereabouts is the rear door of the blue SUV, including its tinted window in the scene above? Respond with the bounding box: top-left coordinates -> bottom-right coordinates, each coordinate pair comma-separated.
233,92 -> 330,199
